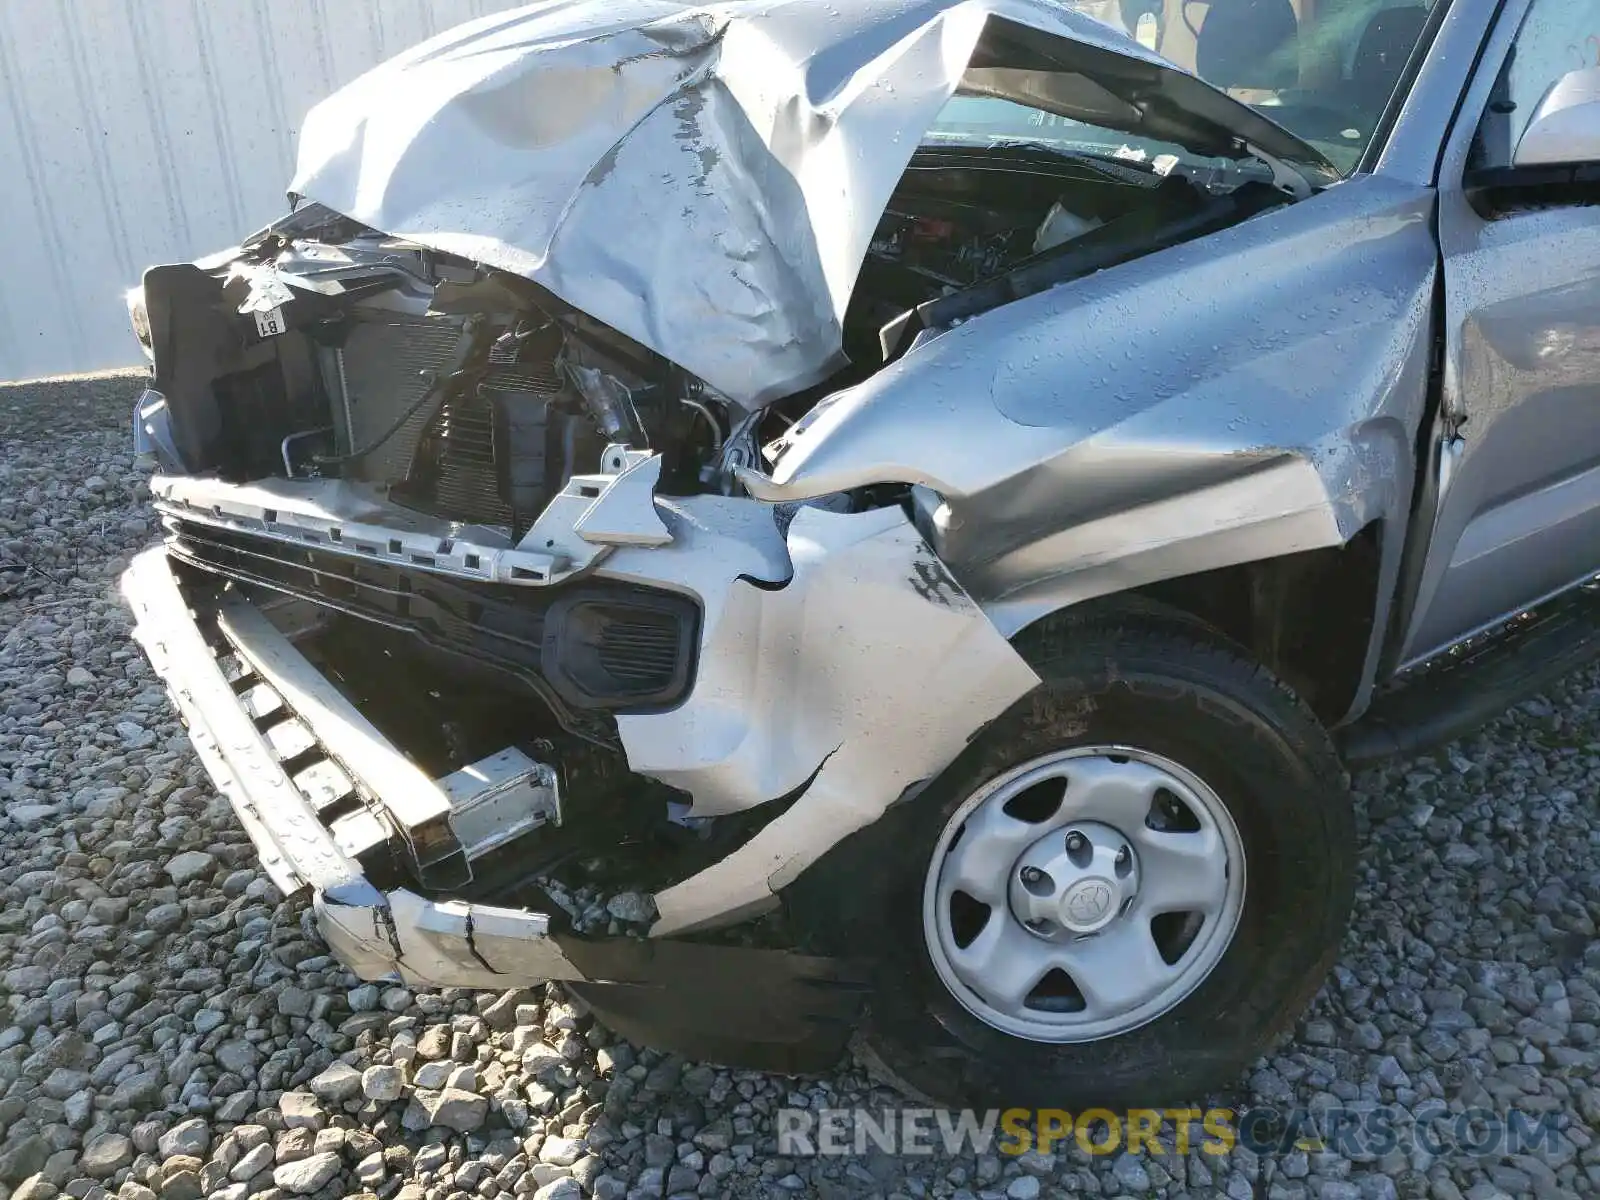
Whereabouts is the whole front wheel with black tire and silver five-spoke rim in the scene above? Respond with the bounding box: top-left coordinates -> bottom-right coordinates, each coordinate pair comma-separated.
794,610 -> 1354,1109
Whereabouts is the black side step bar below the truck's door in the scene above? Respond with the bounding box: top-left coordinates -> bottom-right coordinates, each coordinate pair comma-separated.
1338,582 -> 1600,770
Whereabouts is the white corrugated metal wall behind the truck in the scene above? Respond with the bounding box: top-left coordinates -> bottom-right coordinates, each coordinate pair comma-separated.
0,0 -> 522,379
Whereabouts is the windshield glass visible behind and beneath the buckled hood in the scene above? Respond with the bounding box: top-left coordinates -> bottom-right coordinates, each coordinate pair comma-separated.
930,0 -> 1446,174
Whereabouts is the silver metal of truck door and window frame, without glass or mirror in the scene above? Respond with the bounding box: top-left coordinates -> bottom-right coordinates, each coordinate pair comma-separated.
1398,0 -> 1600,666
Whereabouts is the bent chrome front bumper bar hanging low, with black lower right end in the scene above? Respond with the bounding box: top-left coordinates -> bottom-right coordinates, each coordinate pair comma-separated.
122,549 -> 866,1070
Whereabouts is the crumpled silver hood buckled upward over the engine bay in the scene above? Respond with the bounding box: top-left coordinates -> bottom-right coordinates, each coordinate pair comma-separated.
290,0 -> 1312,406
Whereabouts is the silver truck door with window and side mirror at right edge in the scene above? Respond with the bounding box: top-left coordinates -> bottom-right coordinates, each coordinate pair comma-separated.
1400,0 -> 1600,664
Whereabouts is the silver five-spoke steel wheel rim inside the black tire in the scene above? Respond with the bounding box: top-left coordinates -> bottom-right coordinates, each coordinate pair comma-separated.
923,746 -> 1245,1043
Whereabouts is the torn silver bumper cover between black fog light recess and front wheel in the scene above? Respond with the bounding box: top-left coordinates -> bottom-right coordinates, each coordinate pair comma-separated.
602,501 -> 1038,936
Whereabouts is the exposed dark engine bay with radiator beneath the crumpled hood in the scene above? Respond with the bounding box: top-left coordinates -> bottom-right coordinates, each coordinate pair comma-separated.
134,144 -> 1286,542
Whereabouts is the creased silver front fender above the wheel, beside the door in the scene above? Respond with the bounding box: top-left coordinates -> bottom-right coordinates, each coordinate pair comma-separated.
754,176 -> 1437,640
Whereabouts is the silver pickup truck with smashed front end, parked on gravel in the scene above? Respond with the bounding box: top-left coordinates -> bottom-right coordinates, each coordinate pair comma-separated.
123,0 -> 1600,1107
